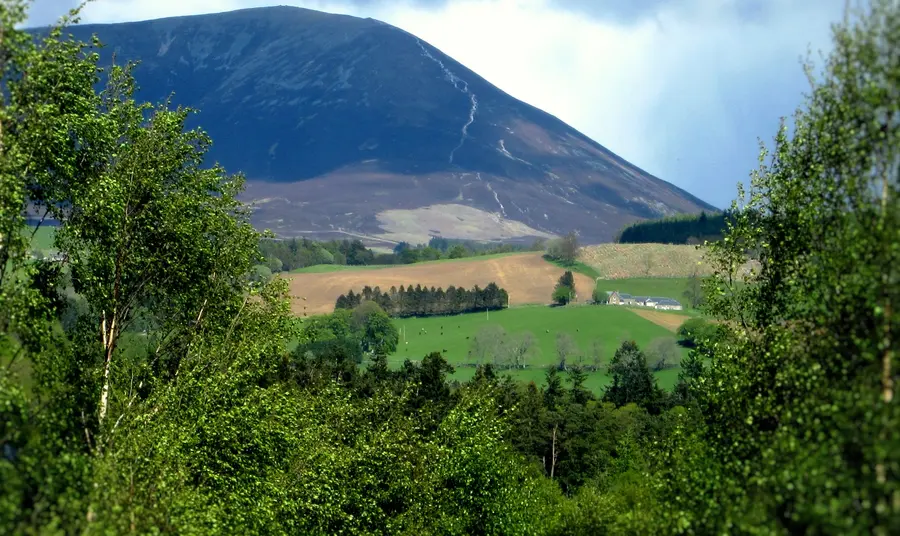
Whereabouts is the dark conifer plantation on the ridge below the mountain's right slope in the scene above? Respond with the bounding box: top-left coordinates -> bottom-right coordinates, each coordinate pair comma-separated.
616,211 -> 734,244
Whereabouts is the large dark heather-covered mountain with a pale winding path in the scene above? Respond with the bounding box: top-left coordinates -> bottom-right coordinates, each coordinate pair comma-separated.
58,7 -> 714,244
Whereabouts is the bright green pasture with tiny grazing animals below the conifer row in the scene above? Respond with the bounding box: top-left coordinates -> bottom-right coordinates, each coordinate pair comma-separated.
389,306 -> 687,392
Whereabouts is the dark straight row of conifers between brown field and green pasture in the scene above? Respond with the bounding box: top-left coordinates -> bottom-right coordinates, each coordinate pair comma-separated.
334,282 -> 509,318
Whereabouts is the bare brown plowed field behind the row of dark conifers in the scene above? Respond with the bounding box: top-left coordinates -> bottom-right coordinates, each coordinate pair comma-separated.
284,253 -> 594,314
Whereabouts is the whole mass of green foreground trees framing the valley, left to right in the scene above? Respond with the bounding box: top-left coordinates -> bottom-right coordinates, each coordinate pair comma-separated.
0,0 -> 900,535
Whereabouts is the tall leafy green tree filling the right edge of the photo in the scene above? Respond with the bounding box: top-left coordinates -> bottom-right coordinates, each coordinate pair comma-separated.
660,0 -> 900,534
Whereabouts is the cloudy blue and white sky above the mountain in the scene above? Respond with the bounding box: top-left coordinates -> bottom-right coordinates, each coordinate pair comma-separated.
29,0 -> 845,207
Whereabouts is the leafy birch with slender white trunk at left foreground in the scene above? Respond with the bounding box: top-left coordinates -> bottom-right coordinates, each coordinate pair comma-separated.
60,67 -> 259,421
